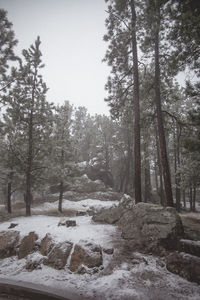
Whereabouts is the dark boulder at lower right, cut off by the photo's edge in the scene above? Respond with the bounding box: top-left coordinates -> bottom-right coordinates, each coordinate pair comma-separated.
166,252 -> 200,284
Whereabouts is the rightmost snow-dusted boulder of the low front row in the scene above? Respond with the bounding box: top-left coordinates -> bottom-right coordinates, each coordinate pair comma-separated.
69,242 -> 103,273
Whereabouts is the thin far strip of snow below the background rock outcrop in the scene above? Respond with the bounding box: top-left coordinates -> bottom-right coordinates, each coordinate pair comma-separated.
32,199 -> 119,213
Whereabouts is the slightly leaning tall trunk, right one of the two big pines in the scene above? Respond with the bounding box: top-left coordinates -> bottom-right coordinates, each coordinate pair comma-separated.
154,15 -> 173,206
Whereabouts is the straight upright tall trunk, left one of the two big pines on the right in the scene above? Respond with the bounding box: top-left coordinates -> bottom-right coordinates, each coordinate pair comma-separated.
131,0 -> 142,203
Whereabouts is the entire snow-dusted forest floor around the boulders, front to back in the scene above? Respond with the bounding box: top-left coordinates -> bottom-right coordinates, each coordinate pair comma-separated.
0,193 -> 200,300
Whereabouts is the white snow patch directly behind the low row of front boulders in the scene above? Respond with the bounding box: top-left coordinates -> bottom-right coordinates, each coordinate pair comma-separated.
0,215 -> 116,245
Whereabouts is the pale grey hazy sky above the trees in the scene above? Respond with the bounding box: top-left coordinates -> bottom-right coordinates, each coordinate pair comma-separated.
0,0 -> 109,114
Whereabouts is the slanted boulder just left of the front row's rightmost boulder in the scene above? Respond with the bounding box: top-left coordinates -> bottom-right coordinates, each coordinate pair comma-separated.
45,242 -> 72,270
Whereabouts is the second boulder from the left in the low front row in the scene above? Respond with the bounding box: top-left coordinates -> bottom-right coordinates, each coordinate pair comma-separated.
18,232 -> 38,259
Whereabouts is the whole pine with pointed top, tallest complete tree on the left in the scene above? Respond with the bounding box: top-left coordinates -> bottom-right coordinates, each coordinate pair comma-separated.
7,37 -> 52,216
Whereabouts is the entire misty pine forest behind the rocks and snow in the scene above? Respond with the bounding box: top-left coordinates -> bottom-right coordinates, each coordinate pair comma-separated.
0,0 -> 200,215
